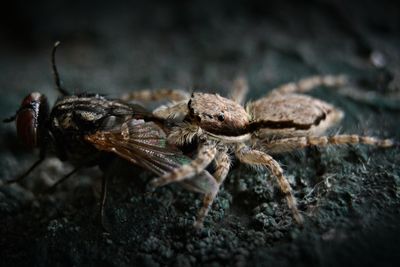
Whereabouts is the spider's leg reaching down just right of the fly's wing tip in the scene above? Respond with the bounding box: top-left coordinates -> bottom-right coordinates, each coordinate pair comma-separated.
194,149 -> 231,228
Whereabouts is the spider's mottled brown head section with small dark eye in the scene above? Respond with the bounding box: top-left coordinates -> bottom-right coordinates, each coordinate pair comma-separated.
186,93 -> 249,136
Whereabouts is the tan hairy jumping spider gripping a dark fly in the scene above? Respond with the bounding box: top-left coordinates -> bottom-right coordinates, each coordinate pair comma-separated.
125,75 -> 394,227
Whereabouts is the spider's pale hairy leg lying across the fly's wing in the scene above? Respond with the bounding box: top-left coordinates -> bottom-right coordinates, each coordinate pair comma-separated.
150,142 -> 217,187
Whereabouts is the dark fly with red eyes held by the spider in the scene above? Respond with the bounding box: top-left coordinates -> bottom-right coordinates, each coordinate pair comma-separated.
3,42 -> 217,230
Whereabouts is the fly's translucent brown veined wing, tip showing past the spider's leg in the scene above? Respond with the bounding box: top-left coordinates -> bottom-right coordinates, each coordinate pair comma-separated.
85,119 -> 218,196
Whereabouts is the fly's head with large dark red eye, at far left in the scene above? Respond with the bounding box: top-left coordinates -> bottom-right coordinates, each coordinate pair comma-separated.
4,92 -> 49,148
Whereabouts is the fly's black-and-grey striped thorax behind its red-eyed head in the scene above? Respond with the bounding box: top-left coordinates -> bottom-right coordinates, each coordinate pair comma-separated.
49,95 -> 132,163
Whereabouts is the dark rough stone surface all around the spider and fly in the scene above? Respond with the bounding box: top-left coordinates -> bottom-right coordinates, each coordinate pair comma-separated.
0,0 -> 400,266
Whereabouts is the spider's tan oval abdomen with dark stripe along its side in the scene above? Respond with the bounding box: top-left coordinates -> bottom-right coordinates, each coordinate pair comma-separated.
248,94 -> 343,138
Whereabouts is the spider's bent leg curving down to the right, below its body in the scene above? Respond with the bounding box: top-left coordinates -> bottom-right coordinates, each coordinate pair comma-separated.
235,145 -> 303,225
